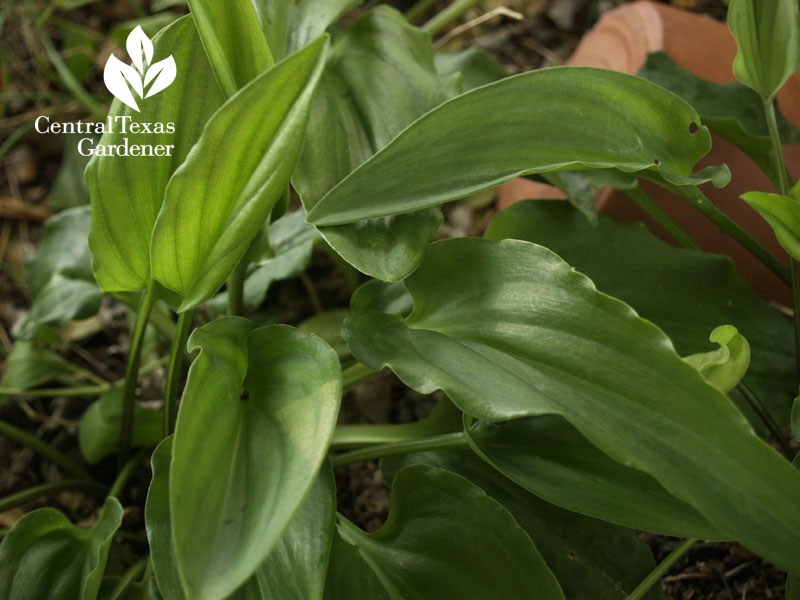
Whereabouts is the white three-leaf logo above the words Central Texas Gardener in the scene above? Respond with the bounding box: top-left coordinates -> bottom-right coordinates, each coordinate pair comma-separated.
103,26 -> 177,112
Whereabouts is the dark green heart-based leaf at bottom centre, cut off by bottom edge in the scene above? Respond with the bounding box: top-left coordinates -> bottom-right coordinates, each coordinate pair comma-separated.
326,465 -> 564,600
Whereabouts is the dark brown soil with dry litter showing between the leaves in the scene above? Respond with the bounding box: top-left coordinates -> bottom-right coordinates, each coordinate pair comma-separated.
0,0 -> 785,600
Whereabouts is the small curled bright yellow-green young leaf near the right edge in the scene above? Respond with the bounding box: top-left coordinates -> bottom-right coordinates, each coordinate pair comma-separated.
683,325 -> 750,394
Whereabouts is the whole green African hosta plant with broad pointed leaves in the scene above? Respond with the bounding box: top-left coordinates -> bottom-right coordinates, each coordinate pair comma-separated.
0,0 -> 800,600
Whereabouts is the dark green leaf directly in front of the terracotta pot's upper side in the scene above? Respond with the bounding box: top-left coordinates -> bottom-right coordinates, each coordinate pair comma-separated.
638,52 -> 800,182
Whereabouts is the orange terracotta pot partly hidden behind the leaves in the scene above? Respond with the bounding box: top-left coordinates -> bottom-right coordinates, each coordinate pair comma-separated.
498,0 -> 800,305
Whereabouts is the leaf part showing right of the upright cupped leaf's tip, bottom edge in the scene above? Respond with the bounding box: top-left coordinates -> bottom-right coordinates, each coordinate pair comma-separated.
230,462 -> 336,600
